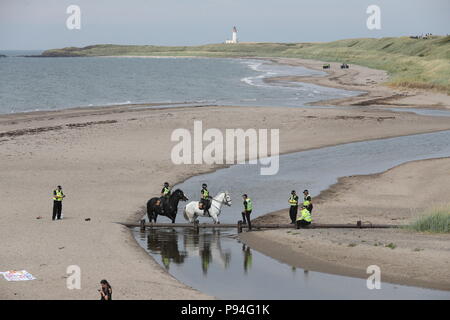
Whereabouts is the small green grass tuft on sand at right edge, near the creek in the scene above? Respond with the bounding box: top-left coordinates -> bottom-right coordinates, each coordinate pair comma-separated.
407,206 -> 450,233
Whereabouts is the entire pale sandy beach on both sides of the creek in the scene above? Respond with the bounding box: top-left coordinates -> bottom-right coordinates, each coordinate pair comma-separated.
0,59 -> 450,299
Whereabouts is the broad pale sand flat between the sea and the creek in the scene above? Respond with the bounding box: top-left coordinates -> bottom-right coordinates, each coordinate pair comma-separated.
0,56 -> 450,299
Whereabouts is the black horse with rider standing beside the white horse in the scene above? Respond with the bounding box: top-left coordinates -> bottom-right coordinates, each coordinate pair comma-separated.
147,189 -> 188,223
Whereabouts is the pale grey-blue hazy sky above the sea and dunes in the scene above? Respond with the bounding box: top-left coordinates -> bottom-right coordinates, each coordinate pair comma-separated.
0,0 -> 450,50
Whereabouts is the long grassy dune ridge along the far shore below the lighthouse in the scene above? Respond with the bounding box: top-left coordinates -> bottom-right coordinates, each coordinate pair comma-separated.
43,36 -> 450,94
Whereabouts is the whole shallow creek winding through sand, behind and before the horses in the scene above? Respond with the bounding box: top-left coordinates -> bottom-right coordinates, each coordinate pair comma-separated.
133,129 -> 450,299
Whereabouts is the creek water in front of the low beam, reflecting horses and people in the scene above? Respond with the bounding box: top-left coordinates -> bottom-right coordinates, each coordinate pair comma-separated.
133,228 -> 450,299
